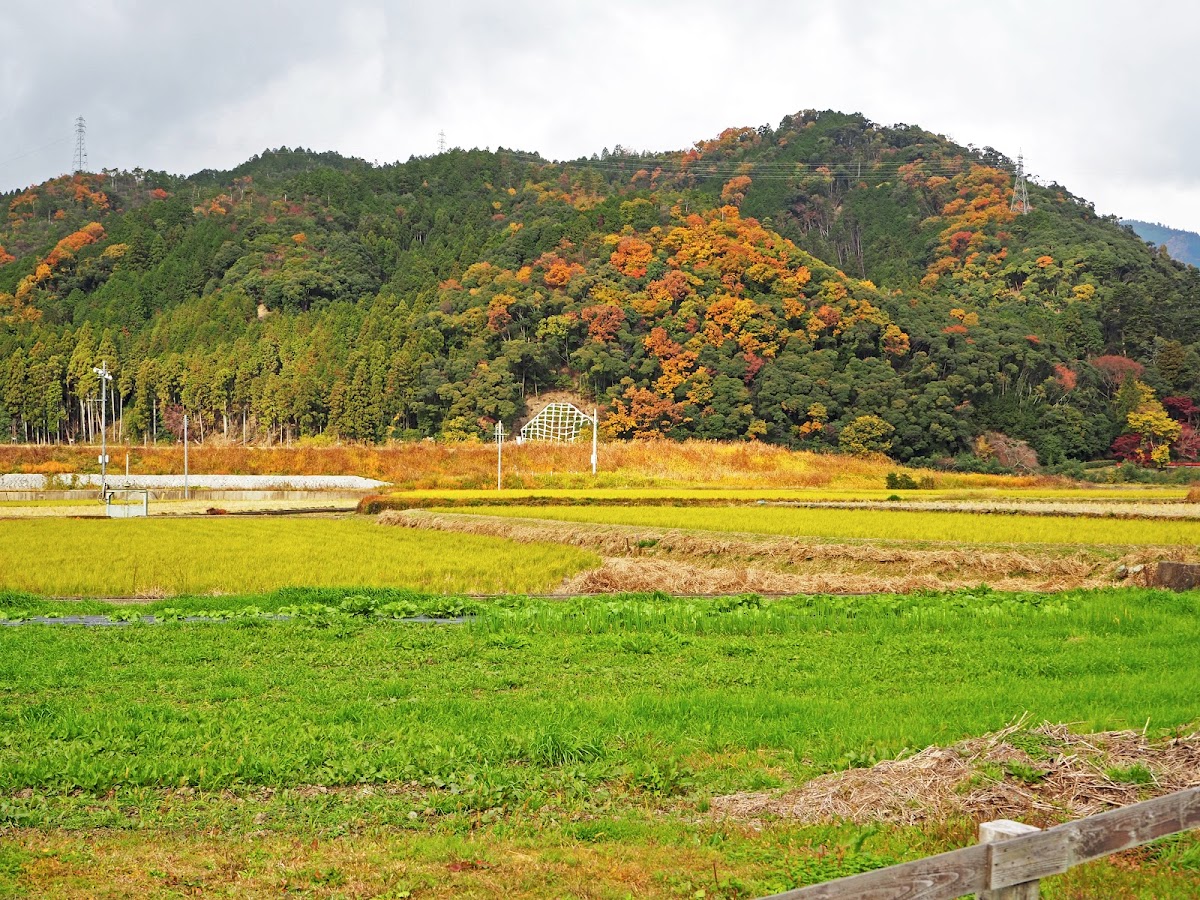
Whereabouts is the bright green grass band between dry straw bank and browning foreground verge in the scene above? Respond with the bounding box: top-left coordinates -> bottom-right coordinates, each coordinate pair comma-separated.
9,592 -> 1200,791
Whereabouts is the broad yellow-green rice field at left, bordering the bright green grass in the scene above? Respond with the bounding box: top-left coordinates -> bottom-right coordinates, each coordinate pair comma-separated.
0,516 -> 599,596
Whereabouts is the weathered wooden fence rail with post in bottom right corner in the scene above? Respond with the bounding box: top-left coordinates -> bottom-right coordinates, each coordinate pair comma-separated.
764,787 -> 1200,900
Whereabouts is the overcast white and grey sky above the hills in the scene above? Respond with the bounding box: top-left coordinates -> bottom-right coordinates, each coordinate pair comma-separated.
0,0 -> 1200,232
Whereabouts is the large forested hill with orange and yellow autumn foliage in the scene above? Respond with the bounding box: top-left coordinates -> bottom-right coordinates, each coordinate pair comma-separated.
0,112 -> 1200,463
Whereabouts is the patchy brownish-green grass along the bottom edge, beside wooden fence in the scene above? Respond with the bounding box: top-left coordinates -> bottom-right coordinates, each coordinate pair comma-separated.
0,806 -> 1200,900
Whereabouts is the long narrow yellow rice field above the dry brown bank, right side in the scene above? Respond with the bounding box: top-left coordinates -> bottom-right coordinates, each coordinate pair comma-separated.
444,506 -> 1200,546
